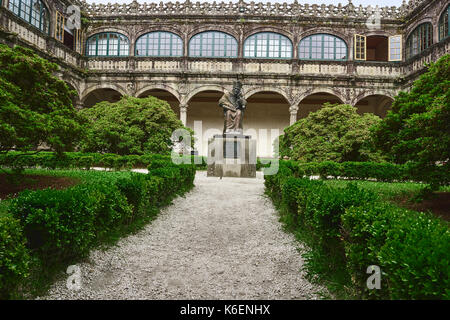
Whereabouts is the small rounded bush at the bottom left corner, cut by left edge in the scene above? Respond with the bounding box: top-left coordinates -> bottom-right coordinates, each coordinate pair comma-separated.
0,216 -> 30,299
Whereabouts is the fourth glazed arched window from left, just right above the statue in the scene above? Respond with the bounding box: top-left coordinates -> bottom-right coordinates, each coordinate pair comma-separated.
244,32 -> 292,59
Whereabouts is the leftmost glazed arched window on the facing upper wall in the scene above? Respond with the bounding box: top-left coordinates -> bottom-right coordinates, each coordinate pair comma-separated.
86,32 -> 130,57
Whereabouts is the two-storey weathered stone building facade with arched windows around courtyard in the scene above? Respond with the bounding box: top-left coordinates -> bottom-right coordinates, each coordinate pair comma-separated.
0,0 -> 450,156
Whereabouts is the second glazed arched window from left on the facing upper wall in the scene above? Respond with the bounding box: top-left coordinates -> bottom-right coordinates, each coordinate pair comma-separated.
136,31 -> 183,57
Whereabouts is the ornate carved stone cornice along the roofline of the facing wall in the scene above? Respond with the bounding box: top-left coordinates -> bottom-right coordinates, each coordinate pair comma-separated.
81,0 -> 429,20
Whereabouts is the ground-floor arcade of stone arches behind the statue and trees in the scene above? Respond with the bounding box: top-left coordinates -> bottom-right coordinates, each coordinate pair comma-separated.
74,86 -> 393,157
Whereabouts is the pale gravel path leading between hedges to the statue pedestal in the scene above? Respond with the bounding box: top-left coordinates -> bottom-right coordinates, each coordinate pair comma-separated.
40,172 -> 322,299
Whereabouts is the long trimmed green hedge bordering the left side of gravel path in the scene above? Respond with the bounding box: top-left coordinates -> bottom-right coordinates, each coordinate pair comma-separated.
0,160 -> 195,299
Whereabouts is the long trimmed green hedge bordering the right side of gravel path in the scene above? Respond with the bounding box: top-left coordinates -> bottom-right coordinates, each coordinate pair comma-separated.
265,162 -> 450,299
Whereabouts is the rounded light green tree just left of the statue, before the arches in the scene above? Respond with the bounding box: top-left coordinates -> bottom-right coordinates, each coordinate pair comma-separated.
81,96 -> 188,155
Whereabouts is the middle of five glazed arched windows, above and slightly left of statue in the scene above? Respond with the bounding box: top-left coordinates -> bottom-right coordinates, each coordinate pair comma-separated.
189,31 -> 238,58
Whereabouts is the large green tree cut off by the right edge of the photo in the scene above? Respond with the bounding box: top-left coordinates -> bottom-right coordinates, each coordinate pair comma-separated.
373,54 -> 450,188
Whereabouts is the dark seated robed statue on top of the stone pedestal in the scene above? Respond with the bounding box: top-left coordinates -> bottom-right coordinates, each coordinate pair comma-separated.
219,81 -> 247,134
